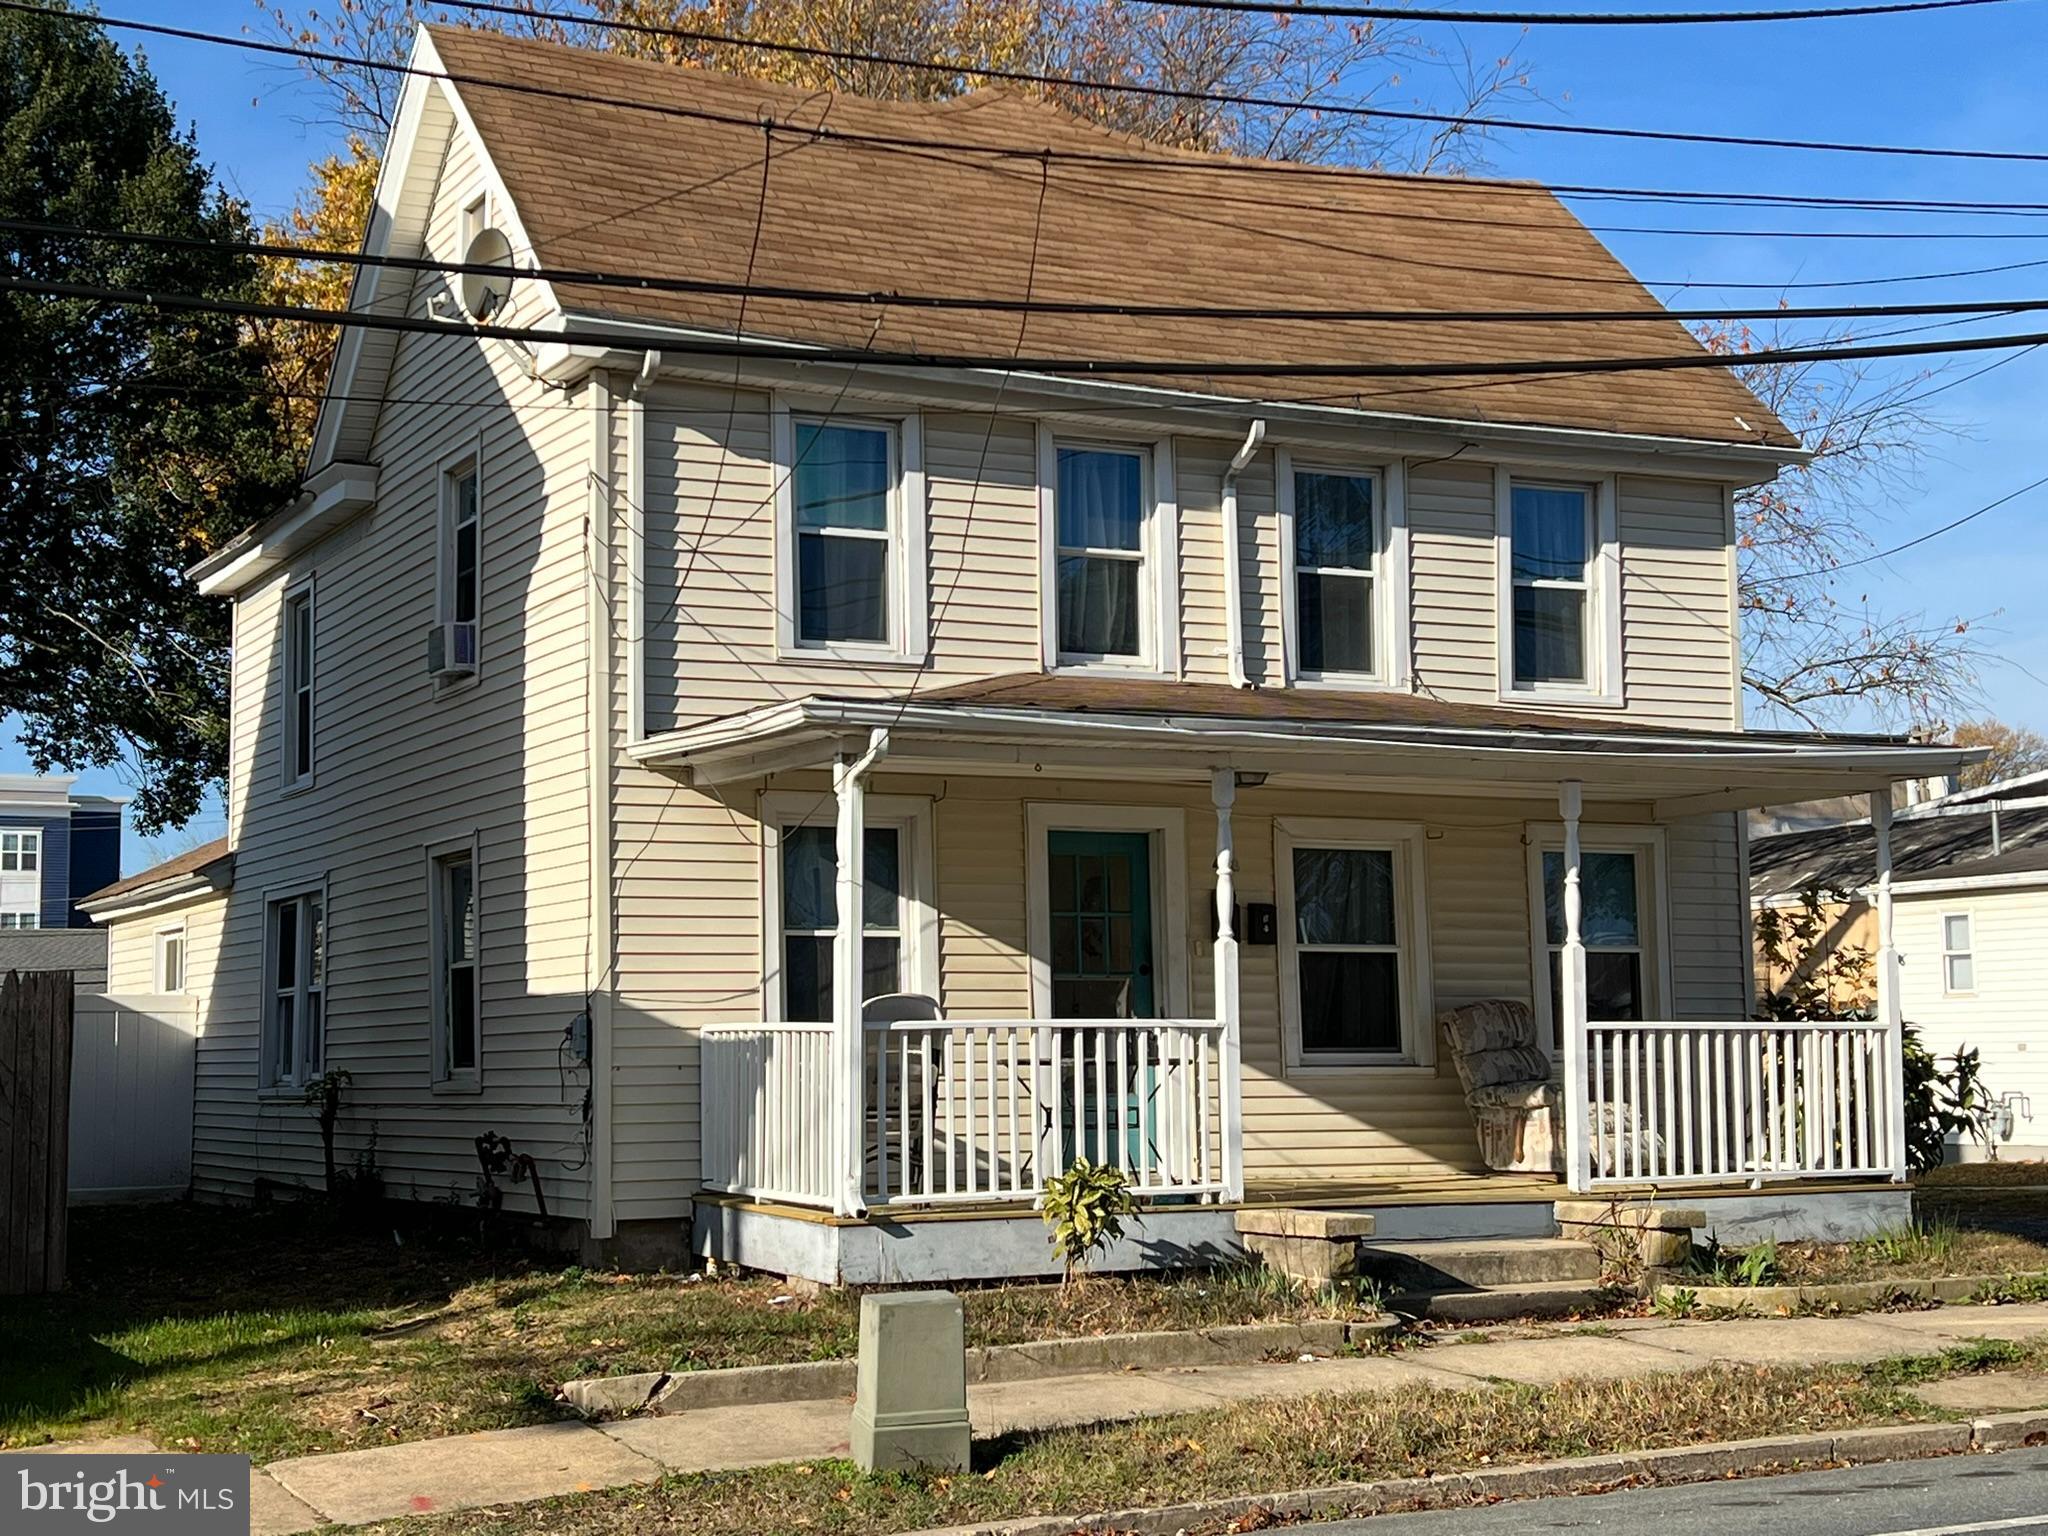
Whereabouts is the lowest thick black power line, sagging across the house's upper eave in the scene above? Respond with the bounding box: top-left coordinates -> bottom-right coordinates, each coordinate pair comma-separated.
19,274 -> 2048,385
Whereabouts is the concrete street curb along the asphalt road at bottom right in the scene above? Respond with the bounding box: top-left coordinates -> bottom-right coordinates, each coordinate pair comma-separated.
905,1411 -> 2048,1536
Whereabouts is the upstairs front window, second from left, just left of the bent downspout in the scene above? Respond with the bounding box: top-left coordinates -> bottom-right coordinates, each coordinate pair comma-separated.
1038,428 -> 1180,670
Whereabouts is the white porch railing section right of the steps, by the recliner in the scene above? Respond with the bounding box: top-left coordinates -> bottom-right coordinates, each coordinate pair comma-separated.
1585,1020 -> 1905,1190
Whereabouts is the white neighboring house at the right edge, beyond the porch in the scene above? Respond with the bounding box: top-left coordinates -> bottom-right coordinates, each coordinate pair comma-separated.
1751,774 -> 2048,1159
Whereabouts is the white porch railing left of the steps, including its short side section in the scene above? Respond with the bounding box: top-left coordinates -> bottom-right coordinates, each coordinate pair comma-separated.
702,1018 -> 1227,1208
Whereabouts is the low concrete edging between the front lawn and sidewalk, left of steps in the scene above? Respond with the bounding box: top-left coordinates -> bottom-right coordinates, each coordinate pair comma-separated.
561,1317 -> 1401,1417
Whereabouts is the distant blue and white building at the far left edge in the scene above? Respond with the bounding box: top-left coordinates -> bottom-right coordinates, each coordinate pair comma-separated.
0,774 -> 125,989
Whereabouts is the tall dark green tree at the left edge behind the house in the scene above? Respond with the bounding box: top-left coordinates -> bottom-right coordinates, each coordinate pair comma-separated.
0,12 -> 295,831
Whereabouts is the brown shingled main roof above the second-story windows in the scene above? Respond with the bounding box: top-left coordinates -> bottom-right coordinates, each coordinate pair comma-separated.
430,27 -> 1794,446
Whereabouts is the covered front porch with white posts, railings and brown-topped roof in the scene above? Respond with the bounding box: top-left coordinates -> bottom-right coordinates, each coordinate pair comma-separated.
637,678 -> 1982,1245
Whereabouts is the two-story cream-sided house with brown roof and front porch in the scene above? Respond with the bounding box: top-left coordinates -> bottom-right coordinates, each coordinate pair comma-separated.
79,27 -> 1966,1280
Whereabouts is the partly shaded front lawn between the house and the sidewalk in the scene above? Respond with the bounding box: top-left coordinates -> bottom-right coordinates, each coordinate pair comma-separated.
0,1204 -> 1370,1462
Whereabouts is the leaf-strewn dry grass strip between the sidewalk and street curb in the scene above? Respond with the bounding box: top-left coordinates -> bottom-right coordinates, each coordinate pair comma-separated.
360,1341 -> 2048,1536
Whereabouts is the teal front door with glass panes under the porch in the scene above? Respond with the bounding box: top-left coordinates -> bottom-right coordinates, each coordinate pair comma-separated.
1047,831 -> 1159,1018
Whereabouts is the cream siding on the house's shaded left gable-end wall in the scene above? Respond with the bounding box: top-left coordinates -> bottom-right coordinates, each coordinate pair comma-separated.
193,123 -> 590,1217
